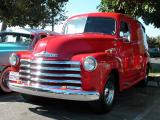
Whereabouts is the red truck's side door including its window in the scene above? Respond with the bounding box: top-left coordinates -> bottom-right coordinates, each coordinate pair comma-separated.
120,20 -> 134,86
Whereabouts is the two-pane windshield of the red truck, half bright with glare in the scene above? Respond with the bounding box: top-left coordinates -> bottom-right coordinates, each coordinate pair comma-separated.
63,17 -> 116,35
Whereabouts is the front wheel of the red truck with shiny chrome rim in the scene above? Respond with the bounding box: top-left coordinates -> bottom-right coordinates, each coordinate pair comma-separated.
92,74 -> 116,113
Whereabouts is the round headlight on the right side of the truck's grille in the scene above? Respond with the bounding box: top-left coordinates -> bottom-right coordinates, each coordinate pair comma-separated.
83,56 -> 97,71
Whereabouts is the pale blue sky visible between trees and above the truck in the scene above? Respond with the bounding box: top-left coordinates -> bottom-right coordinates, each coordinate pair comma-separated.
0,0 -> 160,37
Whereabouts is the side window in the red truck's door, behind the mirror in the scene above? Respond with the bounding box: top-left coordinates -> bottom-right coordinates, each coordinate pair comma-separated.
120,22 -> 131,42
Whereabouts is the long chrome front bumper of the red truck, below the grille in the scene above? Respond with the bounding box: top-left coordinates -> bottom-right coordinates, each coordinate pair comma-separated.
9,83 -> 99,101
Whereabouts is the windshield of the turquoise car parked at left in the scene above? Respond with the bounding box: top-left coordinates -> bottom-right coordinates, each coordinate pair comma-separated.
0,33 -> 33,46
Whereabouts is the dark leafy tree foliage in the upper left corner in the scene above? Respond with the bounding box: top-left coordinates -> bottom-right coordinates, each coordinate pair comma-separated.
0,0 -> 68,30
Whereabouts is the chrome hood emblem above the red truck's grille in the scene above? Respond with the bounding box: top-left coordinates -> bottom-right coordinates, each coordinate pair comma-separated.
34,51 -> 58,58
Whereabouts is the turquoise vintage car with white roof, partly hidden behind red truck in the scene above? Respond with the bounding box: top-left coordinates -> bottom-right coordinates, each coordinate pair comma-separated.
0,29 -> 56,92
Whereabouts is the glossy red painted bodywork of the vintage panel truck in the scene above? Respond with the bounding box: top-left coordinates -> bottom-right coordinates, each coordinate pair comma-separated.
9,13 -> 149,94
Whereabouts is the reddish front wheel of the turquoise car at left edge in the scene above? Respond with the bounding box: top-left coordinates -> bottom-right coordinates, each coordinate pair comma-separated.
0,67 -> 12,93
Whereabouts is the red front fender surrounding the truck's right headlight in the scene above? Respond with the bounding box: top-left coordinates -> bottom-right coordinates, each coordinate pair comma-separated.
72,52 -> 122,93
